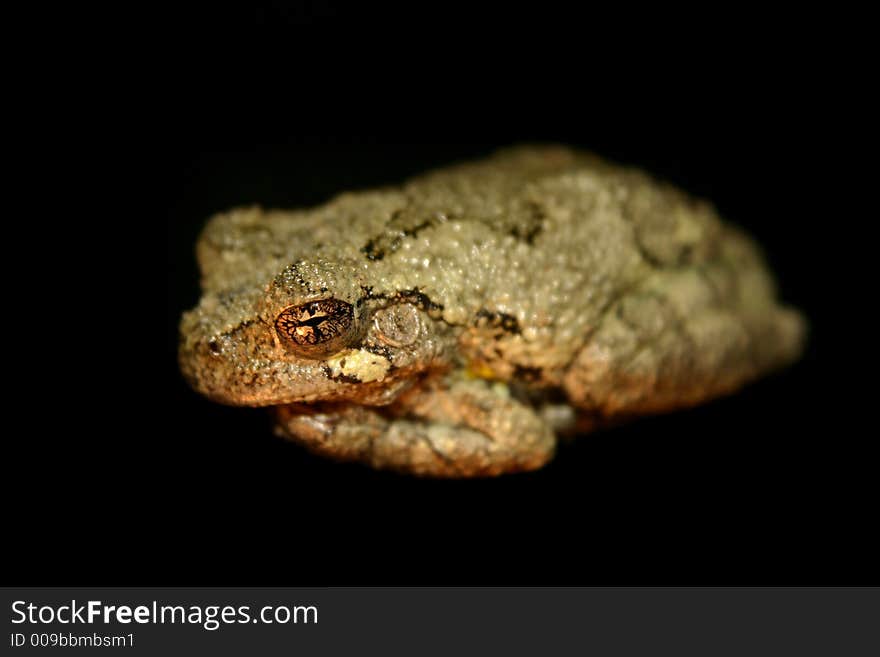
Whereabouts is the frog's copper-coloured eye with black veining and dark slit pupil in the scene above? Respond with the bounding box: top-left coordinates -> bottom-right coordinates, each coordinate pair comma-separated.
275,299 -> 354,354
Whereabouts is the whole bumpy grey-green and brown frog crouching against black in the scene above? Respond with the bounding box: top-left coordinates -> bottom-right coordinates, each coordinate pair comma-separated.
178,144 -> 807,478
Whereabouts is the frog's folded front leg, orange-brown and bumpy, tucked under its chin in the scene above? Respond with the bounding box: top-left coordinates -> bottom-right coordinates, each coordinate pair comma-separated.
278,378 -> 556,477
